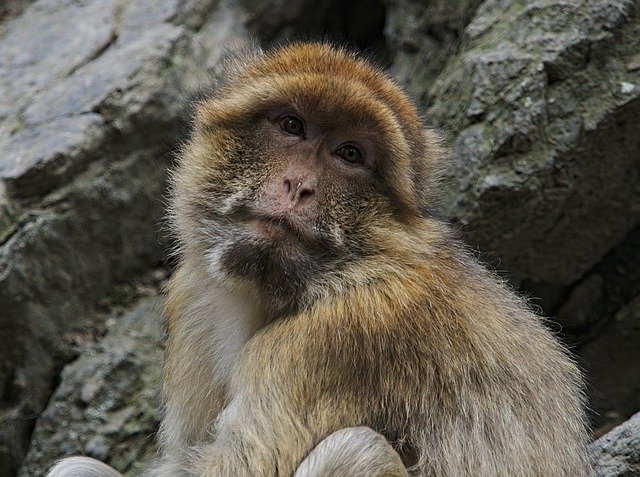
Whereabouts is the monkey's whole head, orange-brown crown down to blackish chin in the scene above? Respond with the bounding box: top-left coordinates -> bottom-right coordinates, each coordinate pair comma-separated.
173,44 -> 440,309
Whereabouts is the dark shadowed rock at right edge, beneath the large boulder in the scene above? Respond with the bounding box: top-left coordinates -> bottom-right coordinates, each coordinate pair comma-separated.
557,226 -> 640,428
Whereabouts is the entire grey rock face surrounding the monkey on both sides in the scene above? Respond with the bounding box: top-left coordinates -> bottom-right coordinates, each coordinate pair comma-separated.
0,0 -> 640,477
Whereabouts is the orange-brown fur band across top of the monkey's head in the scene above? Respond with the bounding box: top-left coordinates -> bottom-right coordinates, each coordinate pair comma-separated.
195,43 -> 424,143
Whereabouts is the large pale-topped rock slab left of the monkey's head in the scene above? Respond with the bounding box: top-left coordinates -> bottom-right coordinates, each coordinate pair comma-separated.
0,0 -> 245,476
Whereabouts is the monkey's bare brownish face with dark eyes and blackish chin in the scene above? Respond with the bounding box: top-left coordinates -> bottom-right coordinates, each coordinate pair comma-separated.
185,110 -> 393,310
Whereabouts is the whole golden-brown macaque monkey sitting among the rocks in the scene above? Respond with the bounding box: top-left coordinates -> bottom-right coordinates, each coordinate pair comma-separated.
48,44 -> 590,477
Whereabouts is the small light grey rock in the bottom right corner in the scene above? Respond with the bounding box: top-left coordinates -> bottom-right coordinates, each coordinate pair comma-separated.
590,413 -> 640,477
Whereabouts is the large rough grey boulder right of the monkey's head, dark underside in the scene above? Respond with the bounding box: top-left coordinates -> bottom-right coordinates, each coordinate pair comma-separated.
422,0 -> 640,288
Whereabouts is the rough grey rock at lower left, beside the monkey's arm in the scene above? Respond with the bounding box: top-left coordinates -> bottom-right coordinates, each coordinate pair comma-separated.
18,297 -> 162,477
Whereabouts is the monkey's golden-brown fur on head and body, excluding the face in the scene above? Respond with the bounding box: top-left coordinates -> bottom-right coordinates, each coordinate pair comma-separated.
155,44 -> 588,476
